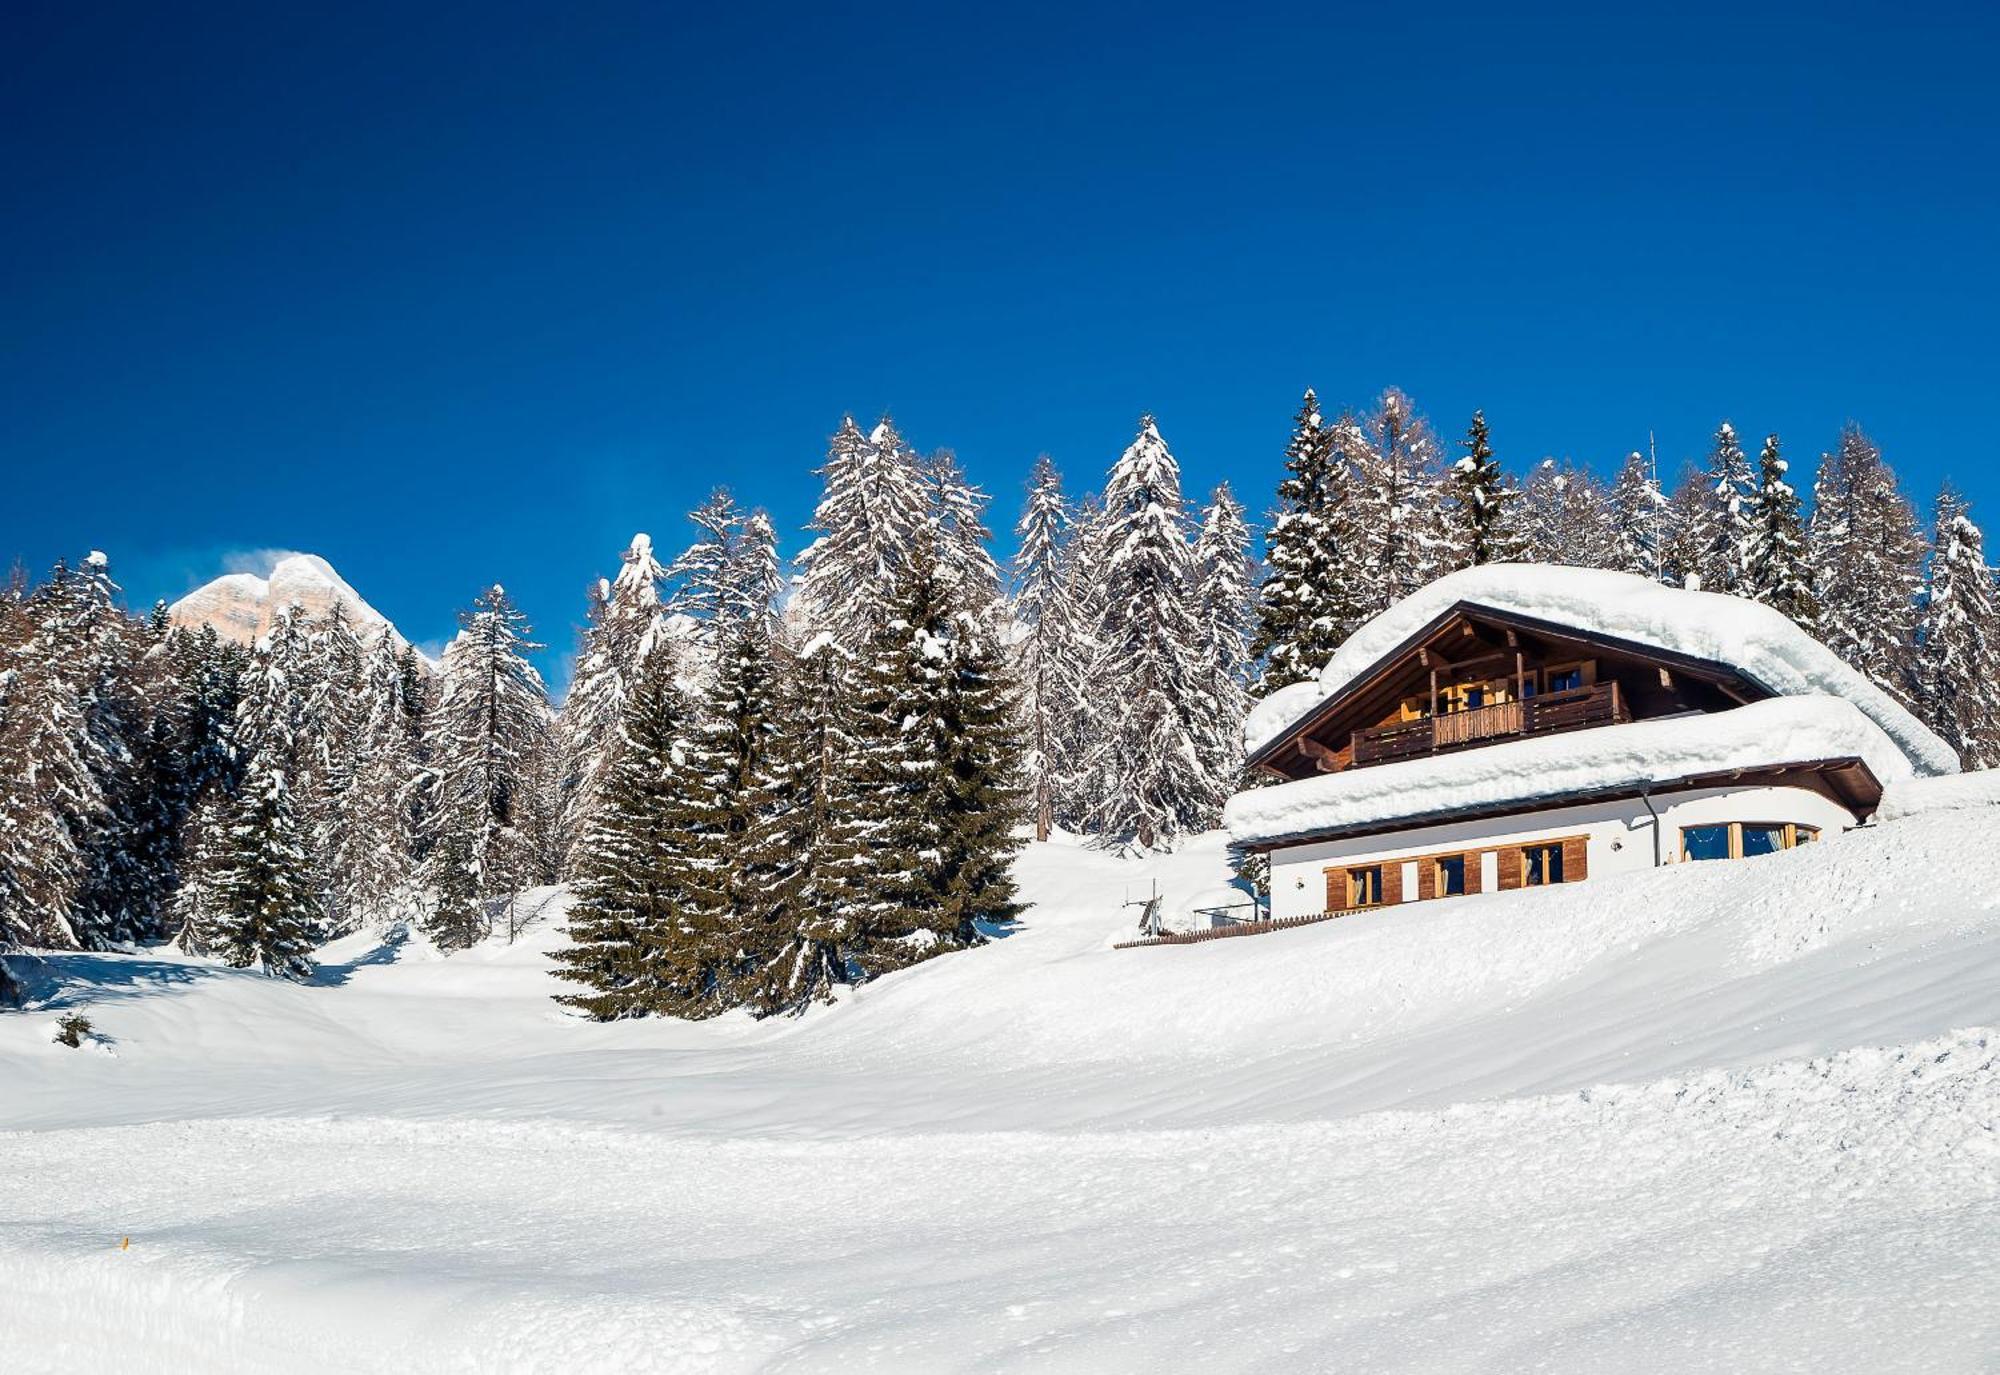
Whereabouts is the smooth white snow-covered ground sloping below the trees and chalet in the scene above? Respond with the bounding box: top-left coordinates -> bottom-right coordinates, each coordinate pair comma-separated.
0,811 -> 2000,1373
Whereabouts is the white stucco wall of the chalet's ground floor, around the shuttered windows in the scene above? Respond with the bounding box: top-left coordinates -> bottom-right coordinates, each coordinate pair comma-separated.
1270,787 -> 1854,917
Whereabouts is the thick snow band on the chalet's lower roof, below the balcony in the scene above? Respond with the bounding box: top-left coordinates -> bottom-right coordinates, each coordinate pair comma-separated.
1222,697 -> 1912,845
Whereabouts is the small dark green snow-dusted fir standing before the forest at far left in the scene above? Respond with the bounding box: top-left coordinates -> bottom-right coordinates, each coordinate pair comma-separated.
214,749 -> 318,979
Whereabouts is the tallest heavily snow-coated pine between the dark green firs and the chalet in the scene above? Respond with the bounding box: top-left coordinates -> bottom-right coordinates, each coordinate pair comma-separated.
1088,416 -> 1218,849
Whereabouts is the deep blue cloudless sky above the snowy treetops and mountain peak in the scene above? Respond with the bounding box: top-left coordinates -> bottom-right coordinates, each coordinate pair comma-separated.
0,4 -> 2000,683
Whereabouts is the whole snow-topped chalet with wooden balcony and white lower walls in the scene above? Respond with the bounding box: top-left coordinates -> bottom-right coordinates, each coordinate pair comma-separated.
1224,564 -> 1958,919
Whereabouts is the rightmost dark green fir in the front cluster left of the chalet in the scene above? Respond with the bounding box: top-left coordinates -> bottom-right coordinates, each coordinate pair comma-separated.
830,535 -> 1024,977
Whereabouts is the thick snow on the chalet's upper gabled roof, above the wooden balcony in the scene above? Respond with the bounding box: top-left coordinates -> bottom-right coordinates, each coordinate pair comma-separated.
1244,564 -> 1958,775
